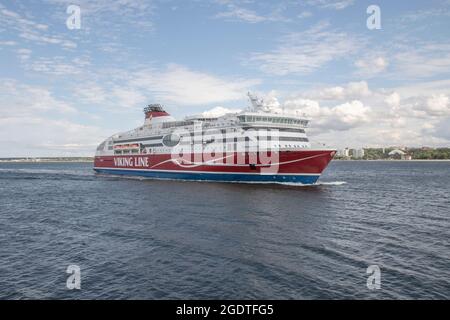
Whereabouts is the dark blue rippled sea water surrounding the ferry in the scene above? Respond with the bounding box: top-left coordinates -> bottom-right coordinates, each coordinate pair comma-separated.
0,161 -> 450,299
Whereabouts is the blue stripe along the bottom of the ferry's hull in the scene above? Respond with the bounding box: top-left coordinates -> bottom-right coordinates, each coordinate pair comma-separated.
94,168 -> 319,184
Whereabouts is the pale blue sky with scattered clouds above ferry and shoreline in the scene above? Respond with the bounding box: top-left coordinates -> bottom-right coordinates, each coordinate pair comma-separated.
0,0 -> 450,157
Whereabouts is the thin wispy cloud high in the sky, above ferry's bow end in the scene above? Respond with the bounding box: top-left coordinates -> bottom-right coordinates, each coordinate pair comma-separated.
248,23 -> 361,76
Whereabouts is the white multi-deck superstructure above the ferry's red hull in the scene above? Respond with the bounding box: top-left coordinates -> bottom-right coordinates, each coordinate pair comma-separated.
97,95 -> 311,155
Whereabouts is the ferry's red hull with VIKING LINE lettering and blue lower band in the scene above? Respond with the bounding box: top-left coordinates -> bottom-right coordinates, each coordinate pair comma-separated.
94,150 -> 335,184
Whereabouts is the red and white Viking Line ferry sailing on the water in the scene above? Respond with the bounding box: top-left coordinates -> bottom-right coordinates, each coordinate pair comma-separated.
94,94 -> 336,184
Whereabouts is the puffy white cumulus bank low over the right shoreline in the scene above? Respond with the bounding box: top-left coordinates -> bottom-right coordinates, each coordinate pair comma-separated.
246,81 -> 450,148
